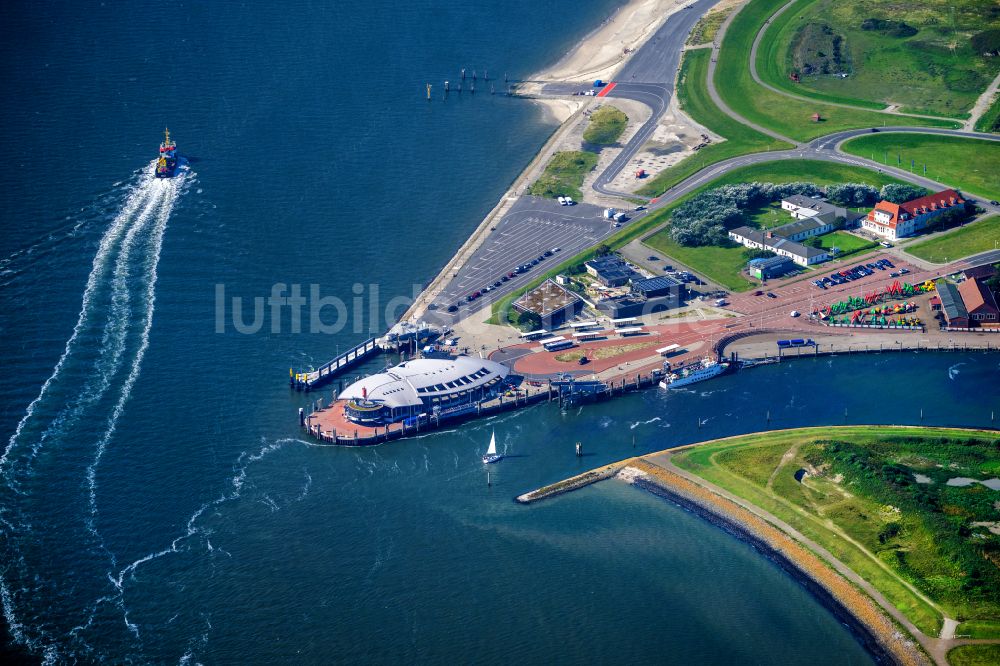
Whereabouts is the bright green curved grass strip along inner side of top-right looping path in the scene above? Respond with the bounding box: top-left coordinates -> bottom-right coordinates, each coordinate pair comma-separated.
751,0 -> 886,110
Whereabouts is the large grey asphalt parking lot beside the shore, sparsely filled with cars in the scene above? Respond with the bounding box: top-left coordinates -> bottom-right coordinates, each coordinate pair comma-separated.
424,196 -> 640,324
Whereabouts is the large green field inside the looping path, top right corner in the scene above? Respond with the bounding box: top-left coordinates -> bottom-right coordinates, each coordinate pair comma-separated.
757,0 -> 1000,117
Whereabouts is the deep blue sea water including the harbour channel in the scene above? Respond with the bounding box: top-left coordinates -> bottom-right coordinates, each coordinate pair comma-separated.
0,0 -> 1000,664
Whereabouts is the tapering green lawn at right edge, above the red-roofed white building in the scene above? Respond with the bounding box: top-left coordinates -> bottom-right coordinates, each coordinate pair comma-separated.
841,132 -> 1000,199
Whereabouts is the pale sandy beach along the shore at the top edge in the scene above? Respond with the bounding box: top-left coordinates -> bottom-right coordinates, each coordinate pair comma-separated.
530,0 -> 686,81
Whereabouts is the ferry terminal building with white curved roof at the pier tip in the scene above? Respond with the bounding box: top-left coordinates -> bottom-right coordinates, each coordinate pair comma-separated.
338,356 -> 510,425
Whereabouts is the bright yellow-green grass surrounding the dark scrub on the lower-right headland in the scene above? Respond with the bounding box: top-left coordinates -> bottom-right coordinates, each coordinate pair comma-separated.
673,426 -> 1000,637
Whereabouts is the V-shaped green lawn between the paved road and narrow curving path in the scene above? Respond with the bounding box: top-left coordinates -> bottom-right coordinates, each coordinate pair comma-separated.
637,48 -> 791,196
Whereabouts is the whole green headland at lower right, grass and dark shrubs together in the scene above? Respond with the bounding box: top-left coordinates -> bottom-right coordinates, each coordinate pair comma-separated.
673,426 -> 1000,637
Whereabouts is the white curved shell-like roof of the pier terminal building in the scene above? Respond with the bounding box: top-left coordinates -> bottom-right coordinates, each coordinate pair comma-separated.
338,356 -> 510,407
